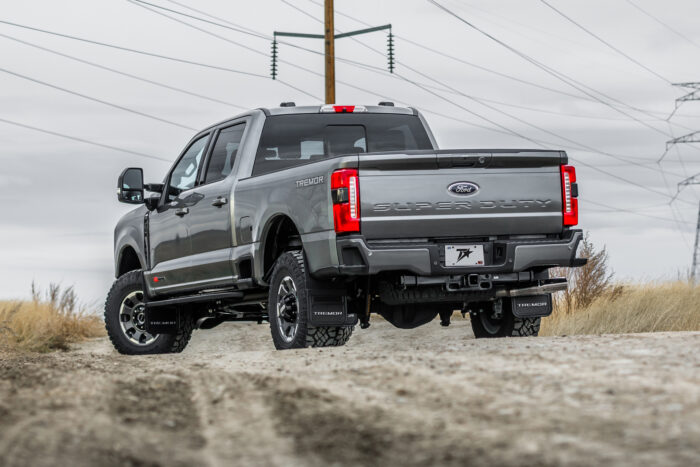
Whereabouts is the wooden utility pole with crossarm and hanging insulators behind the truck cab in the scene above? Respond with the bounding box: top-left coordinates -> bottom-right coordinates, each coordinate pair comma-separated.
270,6 -> 395,104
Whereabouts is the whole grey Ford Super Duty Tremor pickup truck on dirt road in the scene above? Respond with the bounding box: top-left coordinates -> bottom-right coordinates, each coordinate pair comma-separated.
105,102 -> 585,354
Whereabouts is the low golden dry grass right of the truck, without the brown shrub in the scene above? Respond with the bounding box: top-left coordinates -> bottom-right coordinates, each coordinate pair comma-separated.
540,282 -> 700,336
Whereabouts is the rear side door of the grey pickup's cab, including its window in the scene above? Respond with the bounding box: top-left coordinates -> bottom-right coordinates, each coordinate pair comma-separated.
185,121 -> 246,289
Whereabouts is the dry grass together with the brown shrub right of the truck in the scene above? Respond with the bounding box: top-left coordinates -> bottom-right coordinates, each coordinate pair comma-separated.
540,235 -> 700,336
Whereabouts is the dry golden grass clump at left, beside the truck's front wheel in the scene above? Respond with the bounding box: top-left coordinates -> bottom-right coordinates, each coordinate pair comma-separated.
0,284 -> 105,352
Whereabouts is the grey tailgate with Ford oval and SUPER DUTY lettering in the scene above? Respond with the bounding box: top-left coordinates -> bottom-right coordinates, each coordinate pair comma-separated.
359,150 -> 567,239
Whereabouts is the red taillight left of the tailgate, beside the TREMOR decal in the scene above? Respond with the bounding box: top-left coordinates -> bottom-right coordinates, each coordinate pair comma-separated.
331,169 -> 360,233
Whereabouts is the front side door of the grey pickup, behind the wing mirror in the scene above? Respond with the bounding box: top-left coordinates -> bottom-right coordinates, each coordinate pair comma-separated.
145,133 -> 211,293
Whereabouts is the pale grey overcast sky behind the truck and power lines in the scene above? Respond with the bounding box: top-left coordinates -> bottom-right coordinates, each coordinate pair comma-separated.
0,0 -> 700,301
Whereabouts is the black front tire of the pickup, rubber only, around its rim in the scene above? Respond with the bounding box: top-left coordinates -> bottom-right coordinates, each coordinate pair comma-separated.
104,270 -> 194,355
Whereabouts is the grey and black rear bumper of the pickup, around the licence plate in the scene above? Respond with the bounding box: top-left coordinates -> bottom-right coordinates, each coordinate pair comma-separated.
328,230 -> 586,276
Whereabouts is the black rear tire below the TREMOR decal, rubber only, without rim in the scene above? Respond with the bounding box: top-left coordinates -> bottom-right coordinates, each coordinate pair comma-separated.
267,251 -> 353,350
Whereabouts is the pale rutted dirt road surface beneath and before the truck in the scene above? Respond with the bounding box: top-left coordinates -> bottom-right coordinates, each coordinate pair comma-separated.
0,318 -> 700,467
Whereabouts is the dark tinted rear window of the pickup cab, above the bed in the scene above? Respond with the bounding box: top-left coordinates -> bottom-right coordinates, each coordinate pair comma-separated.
253,114 -> 433,175
